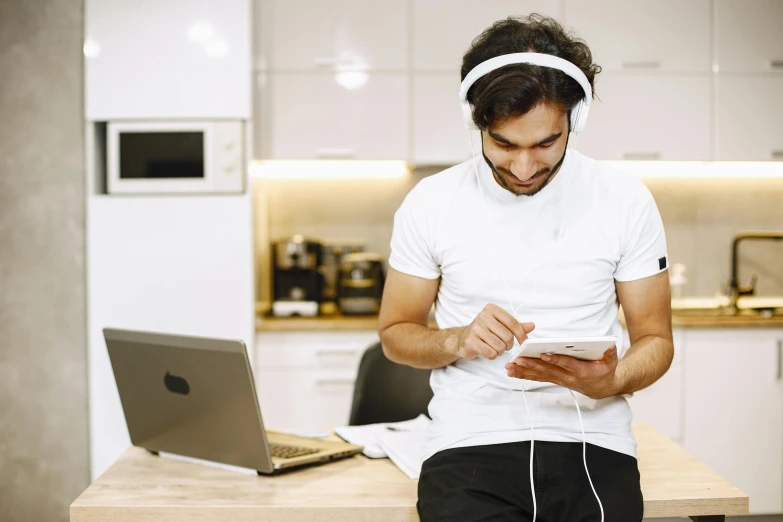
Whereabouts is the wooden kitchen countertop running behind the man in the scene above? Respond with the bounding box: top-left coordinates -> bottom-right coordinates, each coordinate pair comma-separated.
256,310 -> 783,332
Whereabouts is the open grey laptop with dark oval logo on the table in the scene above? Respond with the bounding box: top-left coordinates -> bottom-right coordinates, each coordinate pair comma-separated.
103,328 -> 362,474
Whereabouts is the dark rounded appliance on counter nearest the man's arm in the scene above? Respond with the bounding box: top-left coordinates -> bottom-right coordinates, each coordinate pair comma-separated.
337,252 -> 384,315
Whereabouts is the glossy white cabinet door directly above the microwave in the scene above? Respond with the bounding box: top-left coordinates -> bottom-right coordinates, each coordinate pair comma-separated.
84,0 -> 251,121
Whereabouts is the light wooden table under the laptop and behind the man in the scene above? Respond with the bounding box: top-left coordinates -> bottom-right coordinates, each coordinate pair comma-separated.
71,425 -> 748,522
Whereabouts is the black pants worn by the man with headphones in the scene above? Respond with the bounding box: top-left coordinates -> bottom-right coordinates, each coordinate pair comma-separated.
417,441 -> 644,522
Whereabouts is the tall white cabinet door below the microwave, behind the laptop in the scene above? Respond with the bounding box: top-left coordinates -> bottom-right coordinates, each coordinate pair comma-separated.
86,194 -> 255,479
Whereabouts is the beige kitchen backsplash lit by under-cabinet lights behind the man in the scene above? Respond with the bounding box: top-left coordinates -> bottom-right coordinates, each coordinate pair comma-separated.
254,164 -> 783,299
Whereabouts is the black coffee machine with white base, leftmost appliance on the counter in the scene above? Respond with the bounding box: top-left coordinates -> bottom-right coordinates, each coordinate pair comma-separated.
272,235 -> 323,317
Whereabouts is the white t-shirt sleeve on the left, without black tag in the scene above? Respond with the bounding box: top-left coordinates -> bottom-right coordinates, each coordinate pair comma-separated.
389,186 -> 440,279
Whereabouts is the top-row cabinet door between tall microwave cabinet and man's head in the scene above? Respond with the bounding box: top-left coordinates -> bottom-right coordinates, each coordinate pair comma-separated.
261,0 -> 409,70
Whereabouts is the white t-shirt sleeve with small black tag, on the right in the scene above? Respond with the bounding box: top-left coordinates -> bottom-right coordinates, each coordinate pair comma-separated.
614,184 -> 669,281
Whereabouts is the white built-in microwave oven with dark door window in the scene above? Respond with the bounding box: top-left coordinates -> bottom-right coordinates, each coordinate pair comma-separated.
106,120 -> 246,194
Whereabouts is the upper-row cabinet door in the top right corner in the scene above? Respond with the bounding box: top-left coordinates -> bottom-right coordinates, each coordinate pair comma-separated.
715,0 -> 783,72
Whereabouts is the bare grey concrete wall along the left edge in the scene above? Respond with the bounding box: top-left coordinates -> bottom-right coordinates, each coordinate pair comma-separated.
0,0 -> 89,522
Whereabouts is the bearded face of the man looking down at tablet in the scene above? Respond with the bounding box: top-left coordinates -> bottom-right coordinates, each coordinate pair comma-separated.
481,104 -> 568,196
